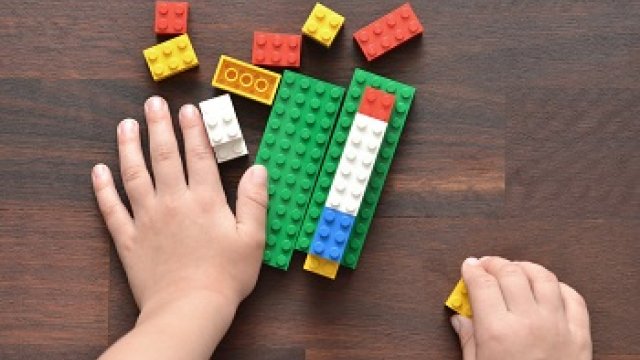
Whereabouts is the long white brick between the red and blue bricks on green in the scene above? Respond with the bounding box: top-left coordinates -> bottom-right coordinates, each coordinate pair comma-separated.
326,113 -> 387,216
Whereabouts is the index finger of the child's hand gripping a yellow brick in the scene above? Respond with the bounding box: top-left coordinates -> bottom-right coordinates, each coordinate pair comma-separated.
462,258 -> 507,326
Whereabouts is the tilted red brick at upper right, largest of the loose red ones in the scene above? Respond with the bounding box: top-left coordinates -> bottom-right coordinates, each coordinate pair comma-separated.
353,3 -> 424,61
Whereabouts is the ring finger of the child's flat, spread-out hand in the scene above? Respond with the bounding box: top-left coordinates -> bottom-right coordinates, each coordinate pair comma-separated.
118,119 -> 153,211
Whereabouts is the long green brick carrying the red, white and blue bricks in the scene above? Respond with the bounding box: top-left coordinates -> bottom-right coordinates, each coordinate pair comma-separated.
296,69 -> 415,269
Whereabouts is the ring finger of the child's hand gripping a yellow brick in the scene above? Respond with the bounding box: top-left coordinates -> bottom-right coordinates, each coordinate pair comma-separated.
517,262 -> 563,312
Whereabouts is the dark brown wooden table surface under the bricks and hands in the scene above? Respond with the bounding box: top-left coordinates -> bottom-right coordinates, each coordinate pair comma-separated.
0,0 -> 640,360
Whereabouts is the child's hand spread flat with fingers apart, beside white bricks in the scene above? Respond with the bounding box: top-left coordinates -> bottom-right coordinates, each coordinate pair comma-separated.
92,97 -> 267,358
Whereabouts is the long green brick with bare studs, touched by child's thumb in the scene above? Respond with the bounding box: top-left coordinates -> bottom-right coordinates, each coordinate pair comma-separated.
256,70 -> 344,270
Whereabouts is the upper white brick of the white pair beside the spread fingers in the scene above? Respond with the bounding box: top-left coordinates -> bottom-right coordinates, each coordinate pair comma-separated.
200,94 -> 242,149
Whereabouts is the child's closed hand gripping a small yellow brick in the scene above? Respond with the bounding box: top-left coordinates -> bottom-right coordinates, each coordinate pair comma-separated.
451,257 -> 592,360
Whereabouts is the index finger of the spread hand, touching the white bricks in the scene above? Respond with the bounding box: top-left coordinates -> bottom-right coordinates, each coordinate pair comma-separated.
179,104 -> 224,198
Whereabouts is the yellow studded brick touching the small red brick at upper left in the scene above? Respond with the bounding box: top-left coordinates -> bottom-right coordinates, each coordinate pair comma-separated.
142,34 -> 198,81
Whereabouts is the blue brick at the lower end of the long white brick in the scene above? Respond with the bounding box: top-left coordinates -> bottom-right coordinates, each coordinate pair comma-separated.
309,207 -> 355,263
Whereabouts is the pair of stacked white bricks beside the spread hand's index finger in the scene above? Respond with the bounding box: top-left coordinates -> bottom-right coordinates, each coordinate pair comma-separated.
200,94 -> 248,163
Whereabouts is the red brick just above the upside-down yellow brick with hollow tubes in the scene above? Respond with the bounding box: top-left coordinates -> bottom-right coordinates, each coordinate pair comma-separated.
251,31 -> 302,68
